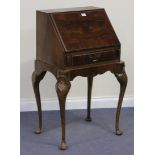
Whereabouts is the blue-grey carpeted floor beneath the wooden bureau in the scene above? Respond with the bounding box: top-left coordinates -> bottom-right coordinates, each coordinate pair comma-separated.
20,108 -> 134,155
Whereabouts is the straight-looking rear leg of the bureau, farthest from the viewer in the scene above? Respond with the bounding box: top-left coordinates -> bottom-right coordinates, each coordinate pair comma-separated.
86,77 -> 93,121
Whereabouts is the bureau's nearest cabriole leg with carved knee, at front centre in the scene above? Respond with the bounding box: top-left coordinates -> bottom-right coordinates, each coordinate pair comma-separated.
56,78 -> 71,150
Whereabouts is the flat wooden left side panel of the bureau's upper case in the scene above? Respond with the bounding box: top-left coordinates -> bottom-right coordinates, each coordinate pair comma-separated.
36,11 -> 65,68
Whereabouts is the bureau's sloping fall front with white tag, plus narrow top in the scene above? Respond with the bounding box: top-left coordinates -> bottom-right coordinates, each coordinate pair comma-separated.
39,7 -> 120,52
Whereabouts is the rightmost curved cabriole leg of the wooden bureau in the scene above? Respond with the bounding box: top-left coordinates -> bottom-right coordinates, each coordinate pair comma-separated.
115,70 -> 128,135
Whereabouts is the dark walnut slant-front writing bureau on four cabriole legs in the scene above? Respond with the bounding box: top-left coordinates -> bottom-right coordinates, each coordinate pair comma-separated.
32,7 -> 127,150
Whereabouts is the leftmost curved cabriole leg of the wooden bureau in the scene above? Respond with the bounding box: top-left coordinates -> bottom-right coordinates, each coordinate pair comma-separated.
32,71 -> 46,134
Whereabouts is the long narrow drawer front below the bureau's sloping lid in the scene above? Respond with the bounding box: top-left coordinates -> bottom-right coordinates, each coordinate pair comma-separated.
66,50 -> 120,66
